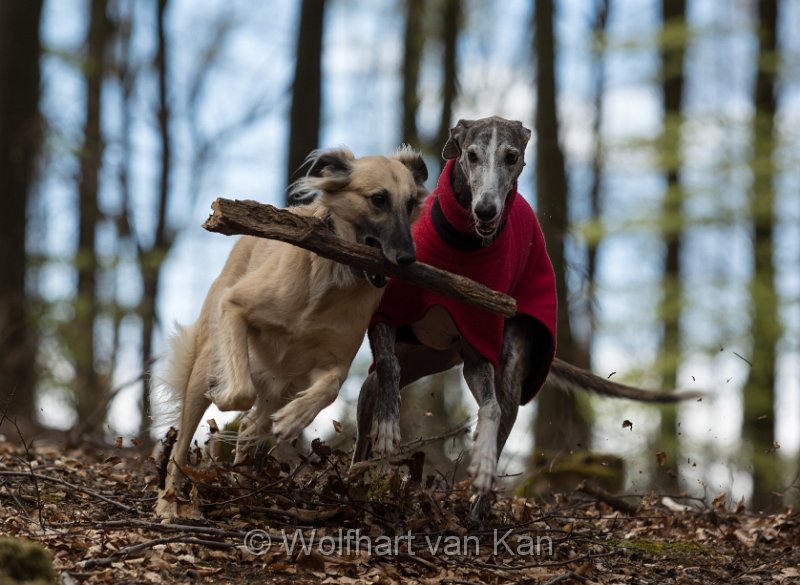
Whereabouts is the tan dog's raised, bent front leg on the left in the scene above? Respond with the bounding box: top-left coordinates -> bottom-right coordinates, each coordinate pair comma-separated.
208,289 -> 256,410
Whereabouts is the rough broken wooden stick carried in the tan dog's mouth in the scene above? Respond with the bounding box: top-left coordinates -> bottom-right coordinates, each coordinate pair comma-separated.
203,198 -> 517,317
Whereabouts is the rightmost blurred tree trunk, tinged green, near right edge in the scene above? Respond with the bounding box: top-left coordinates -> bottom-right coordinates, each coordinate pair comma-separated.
744,0 -> 781,510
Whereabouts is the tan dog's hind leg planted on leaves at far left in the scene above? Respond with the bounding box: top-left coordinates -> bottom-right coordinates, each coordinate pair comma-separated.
156,368 -> 211,518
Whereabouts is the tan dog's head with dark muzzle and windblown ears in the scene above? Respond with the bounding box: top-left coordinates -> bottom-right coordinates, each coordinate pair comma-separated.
291,147 -> 428,274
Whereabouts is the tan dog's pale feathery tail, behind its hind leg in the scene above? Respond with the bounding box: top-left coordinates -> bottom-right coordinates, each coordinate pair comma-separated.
150,324 -> 196,430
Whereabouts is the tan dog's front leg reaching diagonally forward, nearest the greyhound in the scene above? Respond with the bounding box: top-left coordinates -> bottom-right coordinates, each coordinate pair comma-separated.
272,367 -> 347,441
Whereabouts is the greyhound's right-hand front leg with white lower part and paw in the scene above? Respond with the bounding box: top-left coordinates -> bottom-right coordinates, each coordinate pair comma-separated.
463,343 -> 500,494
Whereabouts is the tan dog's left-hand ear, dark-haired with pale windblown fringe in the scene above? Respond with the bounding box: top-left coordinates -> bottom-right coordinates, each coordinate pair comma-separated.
289,148 -> 355,205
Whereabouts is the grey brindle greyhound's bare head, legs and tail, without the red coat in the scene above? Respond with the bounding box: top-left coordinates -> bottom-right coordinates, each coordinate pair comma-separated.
353,117 -> 696,510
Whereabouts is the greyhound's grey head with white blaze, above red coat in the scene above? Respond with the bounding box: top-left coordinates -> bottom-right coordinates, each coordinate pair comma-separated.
442,116 -> 531,240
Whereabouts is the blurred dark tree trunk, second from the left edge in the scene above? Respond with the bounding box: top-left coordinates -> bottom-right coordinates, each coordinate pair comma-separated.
74,0 -> 110,422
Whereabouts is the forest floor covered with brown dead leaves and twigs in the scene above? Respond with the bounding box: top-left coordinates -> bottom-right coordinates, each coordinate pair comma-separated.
0,439 -> 800,585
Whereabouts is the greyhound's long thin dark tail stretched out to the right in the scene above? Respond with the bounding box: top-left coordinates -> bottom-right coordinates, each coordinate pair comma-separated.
547,358 -> 703,404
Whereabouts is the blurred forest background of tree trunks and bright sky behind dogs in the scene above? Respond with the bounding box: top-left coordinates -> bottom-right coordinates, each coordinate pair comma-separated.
0,0 -> 800,509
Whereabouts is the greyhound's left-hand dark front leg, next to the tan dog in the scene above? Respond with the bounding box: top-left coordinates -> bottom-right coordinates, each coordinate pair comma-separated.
365,323 -> 400,456
